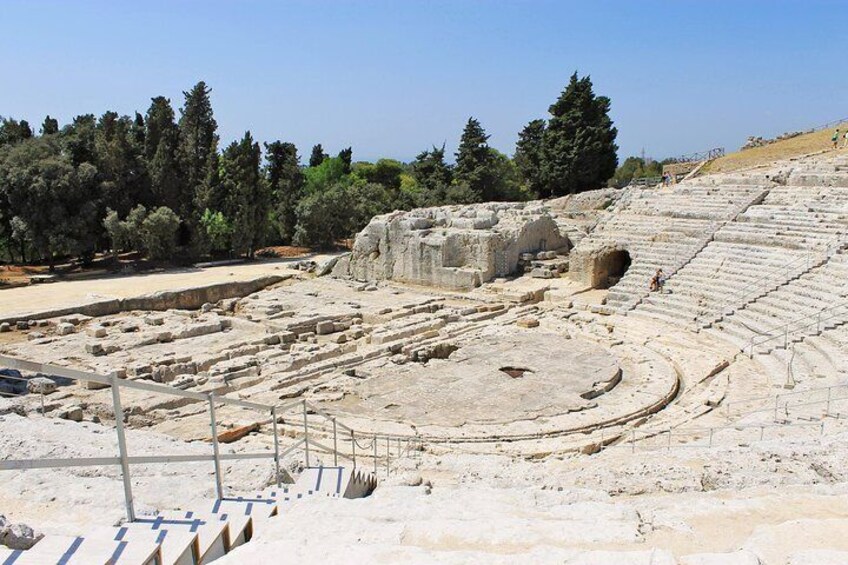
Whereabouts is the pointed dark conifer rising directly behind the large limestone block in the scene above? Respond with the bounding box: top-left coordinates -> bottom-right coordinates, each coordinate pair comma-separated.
454,118 -> 498,202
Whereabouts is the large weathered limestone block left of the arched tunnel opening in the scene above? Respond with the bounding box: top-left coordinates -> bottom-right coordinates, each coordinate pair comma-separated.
333,202 -> 571,289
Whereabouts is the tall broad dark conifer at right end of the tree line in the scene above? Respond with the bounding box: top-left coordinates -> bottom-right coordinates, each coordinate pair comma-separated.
542,73 -> 618,196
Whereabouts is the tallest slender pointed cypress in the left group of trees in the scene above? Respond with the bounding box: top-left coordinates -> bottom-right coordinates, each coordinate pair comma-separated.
175,81 -> 218,219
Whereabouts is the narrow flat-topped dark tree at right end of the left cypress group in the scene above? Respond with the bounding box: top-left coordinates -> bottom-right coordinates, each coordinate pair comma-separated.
265,141 -> 304,244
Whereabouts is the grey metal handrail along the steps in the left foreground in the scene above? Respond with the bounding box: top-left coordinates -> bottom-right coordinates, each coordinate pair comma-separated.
0,355 -> 423,521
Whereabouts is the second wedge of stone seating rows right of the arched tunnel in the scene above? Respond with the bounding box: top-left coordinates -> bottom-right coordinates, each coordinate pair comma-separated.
637,183 -> 848,325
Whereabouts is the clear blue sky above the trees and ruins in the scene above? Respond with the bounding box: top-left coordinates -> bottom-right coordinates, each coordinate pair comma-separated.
0,0 -> 848,160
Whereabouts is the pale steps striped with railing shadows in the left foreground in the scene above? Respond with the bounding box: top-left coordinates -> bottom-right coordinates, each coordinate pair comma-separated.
0,467 -> 376,565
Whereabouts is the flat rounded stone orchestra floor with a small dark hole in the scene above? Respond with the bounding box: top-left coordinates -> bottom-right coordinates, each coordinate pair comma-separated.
326,328 -> 621,426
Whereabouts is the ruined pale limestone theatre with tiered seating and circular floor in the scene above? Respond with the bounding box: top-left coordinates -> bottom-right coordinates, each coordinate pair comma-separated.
0,149 -> 848,565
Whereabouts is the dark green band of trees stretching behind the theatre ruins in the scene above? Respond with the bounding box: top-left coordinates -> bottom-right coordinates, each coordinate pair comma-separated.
0,73 -> 617,267
